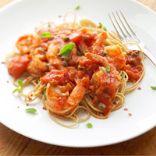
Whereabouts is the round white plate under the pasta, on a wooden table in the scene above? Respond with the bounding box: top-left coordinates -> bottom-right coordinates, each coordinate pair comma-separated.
0,0 -> 156,147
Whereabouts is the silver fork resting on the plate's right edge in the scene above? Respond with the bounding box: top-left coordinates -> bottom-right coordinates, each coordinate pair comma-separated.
109,11 -> 156,66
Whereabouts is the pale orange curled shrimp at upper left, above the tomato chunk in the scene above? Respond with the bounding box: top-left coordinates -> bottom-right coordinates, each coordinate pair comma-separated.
16,35 -> 41,54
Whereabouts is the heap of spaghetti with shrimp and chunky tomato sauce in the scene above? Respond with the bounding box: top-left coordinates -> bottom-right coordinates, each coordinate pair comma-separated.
7,20 -> 144,127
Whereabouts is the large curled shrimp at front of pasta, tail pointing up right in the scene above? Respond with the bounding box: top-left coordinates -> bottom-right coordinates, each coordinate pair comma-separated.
45,80 -> 86,116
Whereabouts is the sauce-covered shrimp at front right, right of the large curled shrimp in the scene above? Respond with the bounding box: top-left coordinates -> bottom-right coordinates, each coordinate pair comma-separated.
91,68 -> 121,116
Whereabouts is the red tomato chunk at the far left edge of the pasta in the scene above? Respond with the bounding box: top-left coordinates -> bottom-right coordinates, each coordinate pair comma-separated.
8,55 -> 30,79
